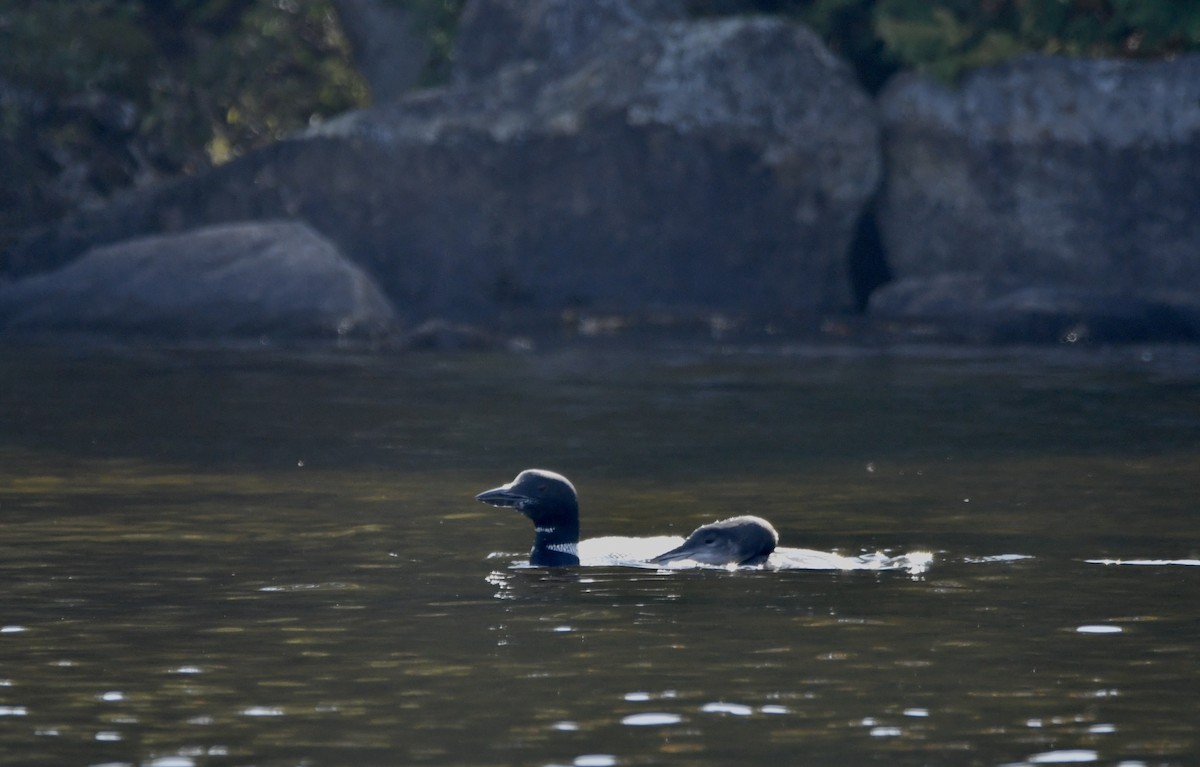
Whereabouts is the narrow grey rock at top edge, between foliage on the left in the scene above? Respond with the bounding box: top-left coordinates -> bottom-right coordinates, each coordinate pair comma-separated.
334,0 -> 430,103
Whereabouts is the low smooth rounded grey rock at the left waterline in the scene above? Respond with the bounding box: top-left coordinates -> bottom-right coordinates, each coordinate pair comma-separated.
0,221 -> 392,340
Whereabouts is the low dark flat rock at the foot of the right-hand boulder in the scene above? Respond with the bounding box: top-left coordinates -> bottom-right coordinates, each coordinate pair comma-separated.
870,274 -> 1200,343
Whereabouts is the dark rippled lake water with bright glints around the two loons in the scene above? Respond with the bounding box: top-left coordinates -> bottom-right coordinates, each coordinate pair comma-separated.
0,342 -> 1200,767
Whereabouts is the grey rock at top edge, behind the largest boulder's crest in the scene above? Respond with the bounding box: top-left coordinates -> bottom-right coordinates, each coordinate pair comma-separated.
454,0 -> 686,82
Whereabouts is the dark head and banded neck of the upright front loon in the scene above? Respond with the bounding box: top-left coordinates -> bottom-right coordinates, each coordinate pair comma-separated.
475,469 -> 580,568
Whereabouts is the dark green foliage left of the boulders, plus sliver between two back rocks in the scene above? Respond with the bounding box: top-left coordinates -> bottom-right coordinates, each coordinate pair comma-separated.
0,0 -> 462,250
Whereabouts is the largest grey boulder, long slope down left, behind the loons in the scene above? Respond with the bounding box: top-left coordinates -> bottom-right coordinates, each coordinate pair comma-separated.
6,12 -> 880,322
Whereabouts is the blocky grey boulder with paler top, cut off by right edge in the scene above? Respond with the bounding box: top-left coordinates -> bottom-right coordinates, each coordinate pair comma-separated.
872,55 -> 1200,337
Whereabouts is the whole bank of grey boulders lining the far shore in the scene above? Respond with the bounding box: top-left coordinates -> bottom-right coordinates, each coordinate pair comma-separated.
0,0 -> 1200,348
